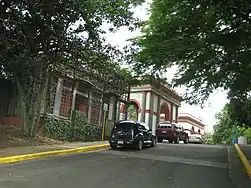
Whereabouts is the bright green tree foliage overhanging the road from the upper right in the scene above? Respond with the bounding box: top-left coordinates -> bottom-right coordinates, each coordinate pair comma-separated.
133,0 -> 251,104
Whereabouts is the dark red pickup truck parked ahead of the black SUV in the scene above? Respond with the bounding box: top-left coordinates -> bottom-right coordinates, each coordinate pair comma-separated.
156,122 -> 189,144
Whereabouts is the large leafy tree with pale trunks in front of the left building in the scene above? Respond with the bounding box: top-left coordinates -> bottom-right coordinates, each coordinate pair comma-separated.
0,0 -> 143,136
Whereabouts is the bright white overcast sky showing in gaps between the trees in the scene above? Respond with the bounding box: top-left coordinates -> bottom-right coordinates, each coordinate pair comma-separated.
105,2 -> 228,132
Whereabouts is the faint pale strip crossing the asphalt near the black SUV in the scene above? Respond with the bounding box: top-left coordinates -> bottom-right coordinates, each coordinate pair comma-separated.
101,150 -> 228,168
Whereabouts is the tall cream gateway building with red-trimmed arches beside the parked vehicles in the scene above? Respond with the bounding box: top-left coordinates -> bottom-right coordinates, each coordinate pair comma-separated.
119,79 -> 182,131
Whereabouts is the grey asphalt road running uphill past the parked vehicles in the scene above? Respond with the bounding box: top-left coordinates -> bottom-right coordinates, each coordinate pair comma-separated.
0,143 -> 234,188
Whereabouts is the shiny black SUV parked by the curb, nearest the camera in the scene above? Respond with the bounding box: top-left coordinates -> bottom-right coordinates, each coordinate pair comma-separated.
109,121 -> 156,150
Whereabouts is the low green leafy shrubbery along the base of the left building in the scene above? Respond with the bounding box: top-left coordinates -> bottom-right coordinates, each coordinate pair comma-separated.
44,110 -> 101,141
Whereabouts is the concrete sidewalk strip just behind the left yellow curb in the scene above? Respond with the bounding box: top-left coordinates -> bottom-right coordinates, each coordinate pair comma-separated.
0,141 -> 108,158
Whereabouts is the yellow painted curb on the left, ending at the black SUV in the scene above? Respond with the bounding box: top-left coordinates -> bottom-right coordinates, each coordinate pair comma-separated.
0,144 -> 110,164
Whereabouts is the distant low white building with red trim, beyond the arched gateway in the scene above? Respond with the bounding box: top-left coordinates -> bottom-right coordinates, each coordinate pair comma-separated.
178,113 -> 205,135
